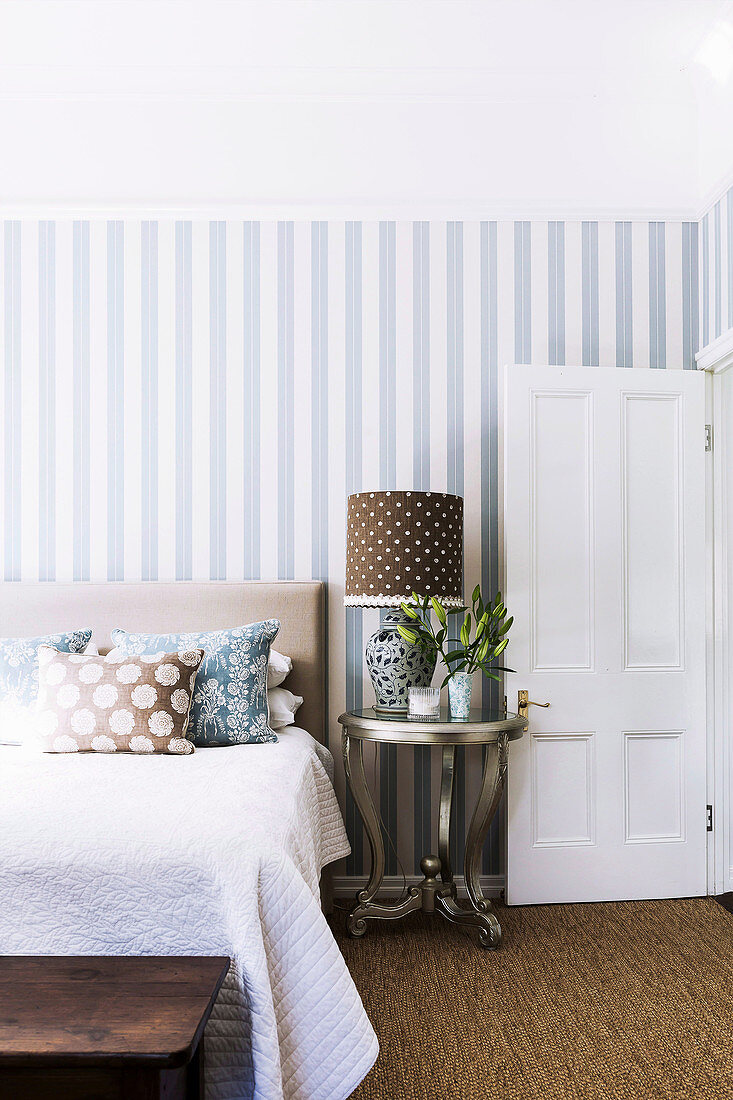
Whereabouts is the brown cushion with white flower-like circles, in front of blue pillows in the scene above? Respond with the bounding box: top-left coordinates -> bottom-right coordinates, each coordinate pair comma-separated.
36,646 -> 204,756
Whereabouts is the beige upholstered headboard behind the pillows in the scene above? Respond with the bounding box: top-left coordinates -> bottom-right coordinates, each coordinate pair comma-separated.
0,581 -> 326,741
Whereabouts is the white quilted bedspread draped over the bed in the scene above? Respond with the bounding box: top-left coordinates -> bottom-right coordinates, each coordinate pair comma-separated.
0,727 -> 378,1100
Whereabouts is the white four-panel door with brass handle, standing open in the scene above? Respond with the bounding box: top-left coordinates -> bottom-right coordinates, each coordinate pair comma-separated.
504,366 -> 705,904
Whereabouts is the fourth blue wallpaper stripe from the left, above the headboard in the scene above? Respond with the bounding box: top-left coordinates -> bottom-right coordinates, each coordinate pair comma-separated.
107,221 -> 124,581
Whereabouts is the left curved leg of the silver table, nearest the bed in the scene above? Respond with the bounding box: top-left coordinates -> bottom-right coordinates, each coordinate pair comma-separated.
342,729 -> 420,936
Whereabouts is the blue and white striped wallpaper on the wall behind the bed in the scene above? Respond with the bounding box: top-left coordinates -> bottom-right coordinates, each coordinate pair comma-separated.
0,218 -> 695,875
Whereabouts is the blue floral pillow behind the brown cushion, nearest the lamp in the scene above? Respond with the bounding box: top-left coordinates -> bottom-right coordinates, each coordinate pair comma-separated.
112,619 -> 280,746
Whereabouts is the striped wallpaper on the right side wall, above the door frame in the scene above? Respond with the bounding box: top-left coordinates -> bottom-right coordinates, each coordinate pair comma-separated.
700,187 -> 733,348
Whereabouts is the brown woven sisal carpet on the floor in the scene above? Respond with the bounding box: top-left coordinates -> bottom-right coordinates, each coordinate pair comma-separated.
331,899 -> 733,1100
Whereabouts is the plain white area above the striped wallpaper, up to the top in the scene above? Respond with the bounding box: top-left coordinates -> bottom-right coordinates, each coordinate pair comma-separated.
0,0 -> 733,217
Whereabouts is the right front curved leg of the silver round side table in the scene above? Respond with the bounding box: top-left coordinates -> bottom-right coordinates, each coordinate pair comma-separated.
436,734 -> 508,947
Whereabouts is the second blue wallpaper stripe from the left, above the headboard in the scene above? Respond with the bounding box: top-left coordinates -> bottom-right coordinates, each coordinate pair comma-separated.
39,221 -> 56,581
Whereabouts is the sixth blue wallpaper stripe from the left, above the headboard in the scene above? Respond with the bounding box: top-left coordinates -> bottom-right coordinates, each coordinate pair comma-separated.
175,221 -> 194,581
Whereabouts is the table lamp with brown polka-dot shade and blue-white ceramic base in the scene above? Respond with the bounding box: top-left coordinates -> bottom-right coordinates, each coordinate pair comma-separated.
343,490 -> 463,715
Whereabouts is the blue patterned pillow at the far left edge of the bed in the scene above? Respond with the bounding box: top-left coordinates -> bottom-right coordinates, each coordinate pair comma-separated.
0,630 -> 91,745
